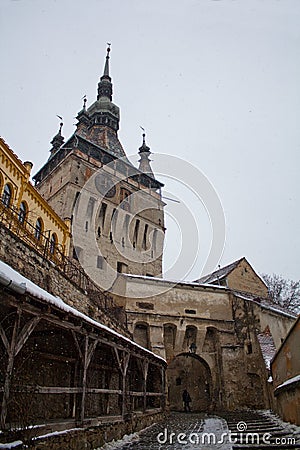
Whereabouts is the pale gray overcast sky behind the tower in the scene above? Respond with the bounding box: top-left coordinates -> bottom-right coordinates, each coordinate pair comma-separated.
0,0 -> 300,279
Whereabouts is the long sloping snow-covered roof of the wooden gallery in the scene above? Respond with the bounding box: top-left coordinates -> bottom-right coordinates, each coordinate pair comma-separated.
0,261 -> 166,362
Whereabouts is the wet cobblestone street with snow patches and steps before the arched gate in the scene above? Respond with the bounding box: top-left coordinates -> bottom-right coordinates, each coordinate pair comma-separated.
104,411 -> 300,450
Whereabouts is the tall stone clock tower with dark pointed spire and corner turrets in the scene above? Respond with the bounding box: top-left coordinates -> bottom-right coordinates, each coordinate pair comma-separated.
34,46 -> 165,288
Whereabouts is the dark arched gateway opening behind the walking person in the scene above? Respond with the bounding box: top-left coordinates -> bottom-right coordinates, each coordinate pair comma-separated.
167,353 -> 213,411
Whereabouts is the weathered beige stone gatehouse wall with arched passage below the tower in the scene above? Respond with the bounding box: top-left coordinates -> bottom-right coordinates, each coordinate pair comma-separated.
118,275 -> 278,410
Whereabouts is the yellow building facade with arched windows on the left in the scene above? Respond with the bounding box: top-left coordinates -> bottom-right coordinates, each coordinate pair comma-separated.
0,138 -> 70,262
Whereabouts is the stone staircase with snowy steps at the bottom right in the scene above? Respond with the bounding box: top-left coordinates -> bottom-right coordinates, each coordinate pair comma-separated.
218,411 -> 300,450
